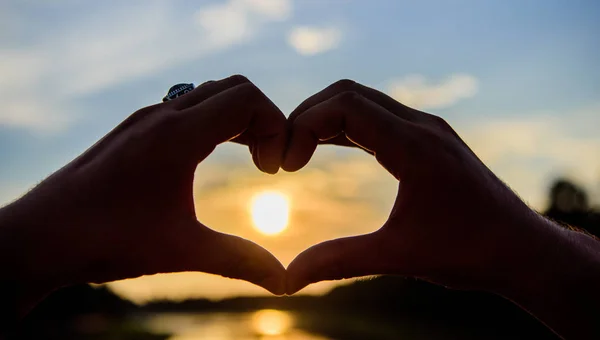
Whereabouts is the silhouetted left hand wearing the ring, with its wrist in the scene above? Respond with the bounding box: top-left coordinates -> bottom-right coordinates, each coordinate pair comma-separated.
1,76 -> 286,318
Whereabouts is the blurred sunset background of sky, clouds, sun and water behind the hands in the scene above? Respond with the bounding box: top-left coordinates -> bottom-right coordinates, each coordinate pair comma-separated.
0,0 -> 600,340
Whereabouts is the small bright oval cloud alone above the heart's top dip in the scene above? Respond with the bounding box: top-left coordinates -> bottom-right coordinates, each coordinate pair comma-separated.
288,26 -> 342,56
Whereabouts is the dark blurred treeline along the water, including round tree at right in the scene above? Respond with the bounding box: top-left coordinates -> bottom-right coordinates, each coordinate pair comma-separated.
18,179 -> 600,340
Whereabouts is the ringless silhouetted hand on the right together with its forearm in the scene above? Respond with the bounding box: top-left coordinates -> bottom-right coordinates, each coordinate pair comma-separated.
282,80 -> 600,339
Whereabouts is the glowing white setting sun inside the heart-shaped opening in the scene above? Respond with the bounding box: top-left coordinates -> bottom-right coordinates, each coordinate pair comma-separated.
250,191 -> 290,235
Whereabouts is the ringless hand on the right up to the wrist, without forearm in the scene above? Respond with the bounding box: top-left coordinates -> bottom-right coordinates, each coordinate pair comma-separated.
282,80 -> 552,294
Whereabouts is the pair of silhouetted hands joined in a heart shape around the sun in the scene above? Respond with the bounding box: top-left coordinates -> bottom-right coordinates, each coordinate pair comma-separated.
5,76 -> 535,306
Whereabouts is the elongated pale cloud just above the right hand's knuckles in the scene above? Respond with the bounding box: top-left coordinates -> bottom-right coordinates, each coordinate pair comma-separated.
388,74 -> 479,109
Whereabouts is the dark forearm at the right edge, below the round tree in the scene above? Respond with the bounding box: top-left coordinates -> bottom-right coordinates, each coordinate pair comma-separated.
494,218 -> 600,339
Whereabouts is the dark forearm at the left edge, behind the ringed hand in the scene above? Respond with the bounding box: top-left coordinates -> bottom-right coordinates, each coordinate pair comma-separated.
0,192 -> 79,326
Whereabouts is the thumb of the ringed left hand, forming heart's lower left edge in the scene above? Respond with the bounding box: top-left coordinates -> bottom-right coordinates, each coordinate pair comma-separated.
163,222 -> 286,295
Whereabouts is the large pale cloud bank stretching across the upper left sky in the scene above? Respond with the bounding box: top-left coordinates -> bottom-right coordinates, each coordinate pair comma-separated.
0,0 -> 292,132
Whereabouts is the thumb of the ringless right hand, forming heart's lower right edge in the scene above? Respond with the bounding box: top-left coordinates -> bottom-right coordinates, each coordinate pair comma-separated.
286,231 -> 387,294
